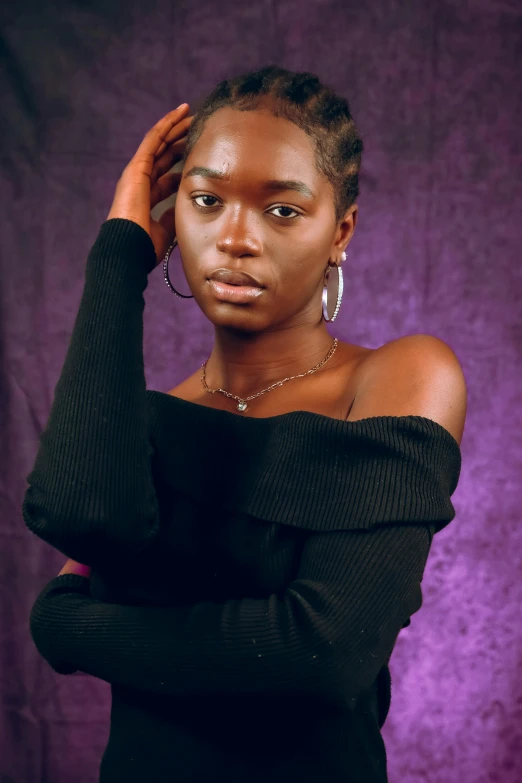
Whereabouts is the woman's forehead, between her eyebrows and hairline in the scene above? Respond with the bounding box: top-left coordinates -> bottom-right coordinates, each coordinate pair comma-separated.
190,107 -> 315,176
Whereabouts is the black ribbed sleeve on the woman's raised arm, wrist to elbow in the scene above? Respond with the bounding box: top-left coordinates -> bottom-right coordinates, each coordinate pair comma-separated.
23,218 -> 159,567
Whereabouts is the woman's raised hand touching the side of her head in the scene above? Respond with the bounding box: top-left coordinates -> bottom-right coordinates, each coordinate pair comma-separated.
107,103 -> 194,264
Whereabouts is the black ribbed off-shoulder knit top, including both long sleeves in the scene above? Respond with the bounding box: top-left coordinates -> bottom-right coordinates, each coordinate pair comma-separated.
23,219 -> 461,783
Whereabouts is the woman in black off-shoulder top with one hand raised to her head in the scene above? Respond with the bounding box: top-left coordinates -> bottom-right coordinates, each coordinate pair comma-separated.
24,66 -> 466,783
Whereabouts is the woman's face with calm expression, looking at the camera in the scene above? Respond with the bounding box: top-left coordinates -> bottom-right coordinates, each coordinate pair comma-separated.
175,108 -> 357,331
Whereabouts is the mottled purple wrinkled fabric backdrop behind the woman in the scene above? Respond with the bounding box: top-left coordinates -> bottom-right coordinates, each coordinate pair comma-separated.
0,0 -> 522,783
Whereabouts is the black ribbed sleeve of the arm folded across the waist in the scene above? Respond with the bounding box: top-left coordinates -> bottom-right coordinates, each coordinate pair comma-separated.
30,525 -> 433,700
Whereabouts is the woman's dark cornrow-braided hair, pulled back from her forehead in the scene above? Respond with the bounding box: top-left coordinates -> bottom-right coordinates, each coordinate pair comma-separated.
182,64 -> 363,222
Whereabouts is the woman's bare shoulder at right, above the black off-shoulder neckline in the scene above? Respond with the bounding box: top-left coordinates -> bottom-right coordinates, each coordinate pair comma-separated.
348,334 -> 467,445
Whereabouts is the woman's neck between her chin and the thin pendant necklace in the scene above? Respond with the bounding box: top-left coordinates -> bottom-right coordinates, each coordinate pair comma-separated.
201,321 -> 333,398
